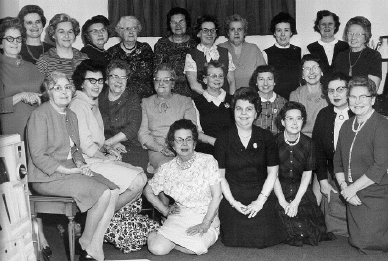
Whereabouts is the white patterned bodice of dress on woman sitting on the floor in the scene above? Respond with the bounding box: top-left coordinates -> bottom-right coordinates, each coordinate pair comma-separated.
148,152 -> 221,214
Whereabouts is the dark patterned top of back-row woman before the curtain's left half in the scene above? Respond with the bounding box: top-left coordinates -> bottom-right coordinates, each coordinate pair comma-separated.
154,37 -> 197,97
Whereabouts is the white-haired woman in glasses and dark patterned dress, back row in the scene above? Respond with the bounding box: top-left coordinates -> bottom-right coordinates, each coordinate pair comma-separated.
108,16 -> 154,99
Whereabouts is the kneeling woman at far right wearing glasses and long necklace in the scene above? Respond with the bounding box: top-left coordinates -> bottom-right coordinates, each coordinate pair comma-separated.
333,76 -> 388,254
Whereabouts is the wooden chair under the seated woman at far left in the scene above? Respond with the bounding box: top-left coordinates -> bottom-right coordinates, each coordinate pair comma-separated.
30,195 -> 78,261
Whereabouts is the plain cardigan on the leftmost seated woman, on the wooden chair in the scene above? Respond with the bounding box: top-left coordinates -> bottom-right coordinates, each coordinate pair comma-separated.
27,102 -> 85,182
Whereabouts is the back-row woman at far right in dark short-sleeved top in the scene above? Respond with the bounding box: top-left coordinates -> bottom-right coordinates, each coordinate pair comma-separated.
333,16 -> 382,88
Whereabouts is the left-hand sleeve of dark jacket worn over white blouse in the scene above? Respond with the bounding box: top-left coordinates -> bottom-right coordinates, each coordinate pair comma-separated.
312,110 -> 328,181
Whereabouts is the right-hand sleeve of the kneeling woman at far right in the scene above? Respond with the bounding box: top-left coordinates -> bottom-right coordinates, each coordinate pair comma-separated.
365,119 -> 388,184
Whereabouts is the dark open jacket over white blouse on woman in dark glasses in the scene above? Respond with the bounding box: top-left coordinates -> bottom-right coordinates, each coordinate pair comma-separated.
312,104 -> 354,181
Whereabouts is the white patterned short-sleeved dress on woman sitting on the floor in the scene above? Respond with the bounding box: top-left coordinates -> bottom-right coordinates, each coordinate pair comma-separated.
148,152 -> 221,255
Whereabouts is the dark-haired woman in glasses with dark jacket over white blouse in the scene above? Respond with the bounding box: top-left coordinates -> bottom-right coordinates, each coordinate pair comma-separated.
313,73 -> 354,236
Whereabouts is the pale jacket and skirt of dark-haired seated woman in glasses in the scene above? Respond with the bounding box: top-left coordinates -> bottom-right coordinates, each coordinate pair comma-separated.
69,91 -> 143,193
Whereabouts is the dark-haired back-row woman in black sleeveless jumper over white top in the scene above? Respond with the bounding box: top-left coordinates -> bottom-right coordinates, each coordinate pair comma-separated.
263,12 -> 302,100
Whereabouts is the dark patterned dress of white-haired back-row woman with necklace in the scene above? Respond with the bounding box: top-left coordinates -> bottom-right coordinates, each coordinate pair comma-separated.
108,42 -> 154,99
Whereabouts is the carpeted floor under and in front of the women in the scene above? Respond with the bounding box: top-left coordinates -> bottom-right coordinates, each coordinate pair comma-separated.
44,215 -> 388,261
